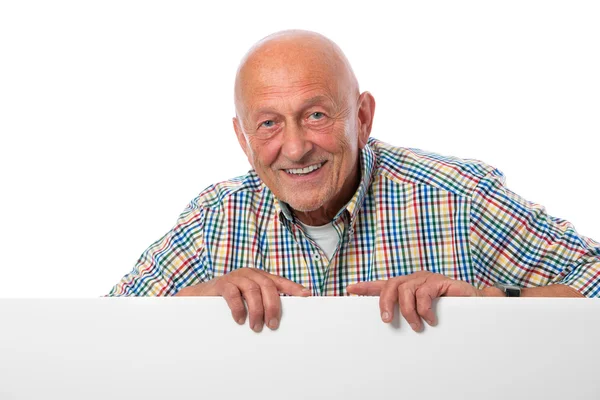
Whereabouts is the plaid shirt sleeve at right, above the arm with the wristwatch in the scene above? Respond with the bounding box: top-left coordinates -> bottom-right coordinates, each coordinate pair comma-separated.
470,169 -> 600,297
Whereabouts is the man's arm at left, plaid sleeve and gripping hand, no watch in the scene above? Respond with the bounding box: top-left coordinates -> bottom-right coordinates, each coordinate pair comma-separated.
109,199 -> 310,332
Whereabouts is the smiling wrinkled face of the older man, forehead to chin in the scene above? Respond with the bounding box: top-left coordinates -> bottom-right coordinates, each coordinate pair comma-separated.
234,56 -> 368,216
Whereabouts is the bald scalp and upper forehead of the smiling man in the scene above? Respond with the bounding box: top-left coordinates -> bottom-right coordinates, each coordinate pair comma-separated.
235,30 -> 359,115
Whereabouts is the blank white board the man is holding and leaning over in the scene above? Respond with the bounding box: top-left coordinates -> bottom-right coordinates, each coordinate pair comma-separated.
0,297 -> 600,400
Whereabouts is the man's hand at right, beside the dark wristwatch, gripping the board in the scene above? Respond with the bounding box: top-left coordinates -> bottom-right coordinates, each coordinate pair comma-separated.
347,271 -> 484,332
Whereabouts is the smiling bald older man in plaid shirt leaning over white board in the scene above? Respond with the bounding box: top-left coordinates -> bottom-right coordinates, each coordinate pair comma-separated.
109,31 -> 600,331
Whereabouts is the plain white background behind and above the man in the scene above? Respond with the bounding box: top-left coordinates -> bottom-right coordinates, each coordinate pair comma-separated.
0,0 -> 600,297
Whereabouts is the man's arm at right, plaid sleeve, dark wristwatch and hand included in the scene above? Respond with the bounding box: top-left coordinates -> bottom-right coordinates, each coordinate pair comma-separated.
347,170 -> 600,331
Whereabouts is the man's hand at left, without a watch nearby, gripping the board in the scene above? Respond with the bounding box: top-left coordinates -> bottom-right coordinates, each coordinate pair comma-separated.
175,268 -> 310,332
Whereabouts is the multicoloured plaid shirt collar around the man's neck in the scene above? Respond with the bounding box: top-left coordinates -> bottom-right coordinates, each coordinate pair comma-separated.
275,144 -> 376,227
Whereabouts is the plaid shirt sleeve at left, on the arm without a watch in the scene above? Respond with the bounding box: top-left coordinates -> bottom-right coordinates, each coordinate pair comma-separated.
108,199 -> 210,296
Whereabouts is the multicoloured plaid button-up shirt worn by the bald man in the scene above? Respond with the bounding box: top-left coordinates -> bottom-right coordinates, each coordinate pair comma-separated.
109,138 -> 600,297
